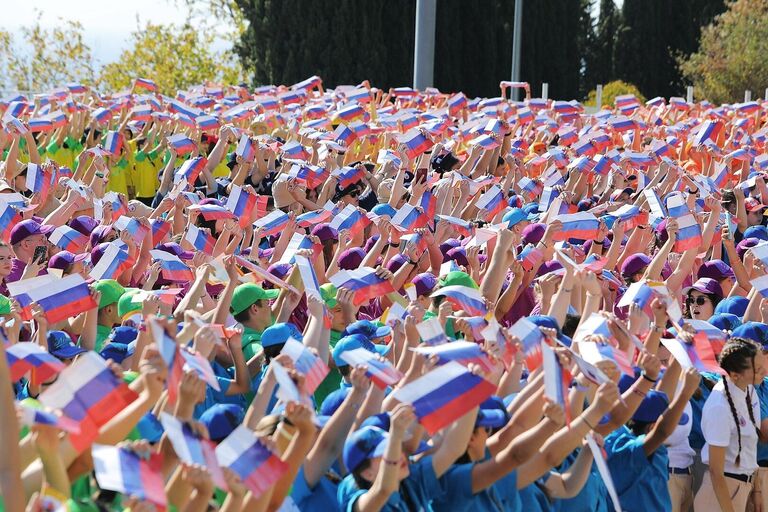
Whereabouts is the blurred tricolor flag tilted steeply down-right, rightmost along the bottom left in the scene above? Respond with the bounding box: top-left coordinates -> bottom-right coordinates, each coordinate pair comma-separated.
216,425 -> 288,499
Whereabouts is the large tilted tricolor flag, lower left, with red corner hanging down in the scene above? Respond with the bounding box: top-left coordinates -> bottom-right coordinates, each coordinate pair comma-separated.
40,352 -> 138,452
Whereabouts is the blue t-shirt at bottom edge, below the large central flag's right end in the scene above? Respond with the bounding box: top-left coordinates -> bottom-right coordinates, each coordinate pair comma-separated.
432,462 -> 523,512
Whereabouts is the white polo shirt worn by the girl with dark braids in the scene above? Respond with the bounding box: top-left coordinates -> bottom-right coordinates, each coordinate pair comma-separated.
701,377 -> 760,475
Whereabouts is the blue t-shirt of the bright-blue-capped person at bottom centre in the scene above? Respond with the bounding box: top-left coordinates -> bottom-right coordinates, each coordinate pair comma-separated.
337,457 -> 443,512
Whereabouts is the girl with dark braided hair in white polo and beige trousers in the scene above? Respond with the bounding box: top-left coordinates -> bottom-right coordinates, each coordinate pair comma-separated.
694,338 -> 765,512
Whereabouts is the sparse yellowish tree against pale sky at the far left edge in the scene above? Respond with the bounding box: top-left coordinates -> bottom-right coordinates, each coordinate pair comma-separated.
0,13 -> 95,92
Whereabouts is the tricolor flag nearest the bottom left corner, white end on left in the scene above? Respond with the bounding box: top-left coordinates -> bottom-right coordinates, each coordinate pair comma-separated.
91,444 -> 168,507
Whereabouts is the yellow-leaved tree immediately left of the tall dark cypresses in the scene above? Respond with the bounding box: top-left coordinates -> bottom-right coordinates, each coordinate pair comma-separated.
99,23 -> 242,94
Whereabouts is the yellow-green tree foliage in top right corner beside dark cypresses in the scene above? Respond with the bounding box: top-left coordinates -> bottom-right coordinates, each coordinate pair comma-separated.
680,0 -> 768,103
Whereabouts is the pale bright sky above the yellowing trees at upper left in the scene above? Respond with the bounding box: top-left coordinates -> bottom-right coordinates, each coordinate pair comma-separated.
0,0 -> 228,65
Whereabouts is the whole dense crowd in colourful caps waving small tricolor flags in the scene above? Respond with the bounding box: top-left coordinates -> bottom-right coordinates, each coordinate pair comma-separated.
0,77 -> 768,512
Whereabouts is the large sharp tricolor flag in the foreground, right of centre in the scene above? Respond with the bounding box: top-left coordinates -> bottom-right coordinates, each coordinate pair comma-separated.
392,361 -> 496,435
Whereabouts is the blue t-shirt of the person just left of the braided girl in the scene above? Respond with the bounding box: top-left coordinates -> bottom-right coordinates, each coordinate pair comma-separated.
605,426 -> 672,512
